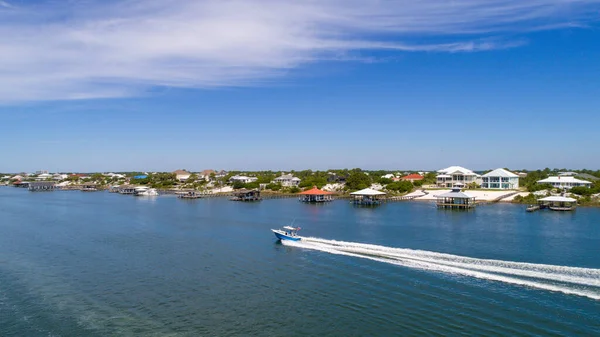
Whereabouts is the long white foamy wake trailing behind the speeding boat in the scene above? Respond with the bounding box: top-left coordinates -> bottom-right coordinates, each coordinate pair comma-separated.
282,237 -> 600,300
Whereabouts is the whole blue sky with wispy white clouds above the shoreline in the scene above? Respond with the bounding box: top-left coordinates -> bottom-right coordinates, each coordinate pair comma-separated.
0,0 -> 600,172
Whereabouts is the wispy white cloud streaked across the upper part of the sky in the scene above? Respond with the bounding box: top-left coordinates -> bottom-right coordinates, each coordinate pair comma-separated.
0,0 -> 600,102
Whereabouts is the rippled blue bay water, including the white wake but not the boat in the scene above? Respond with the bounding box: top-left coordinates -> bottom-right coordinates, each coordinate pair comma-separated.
0,187 -> 600,336
